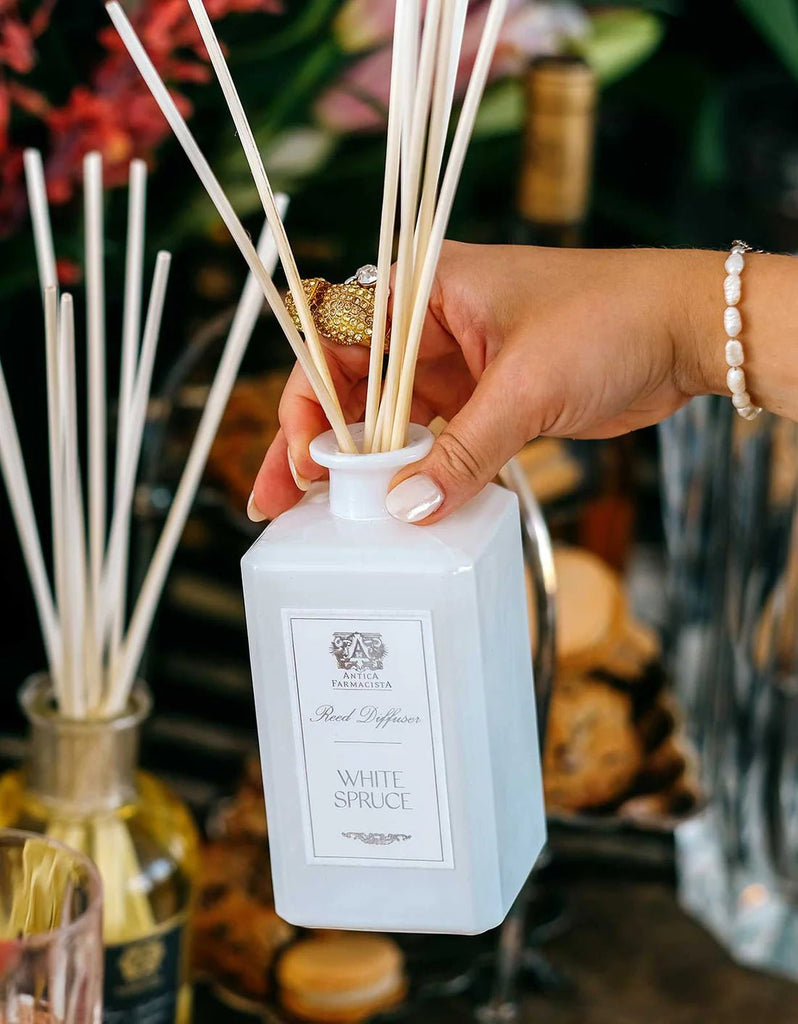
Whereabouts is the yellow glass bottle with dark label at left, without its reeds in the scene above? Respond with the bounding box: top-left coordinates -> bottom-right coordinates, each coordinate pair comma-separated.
0,675 -> 198,1024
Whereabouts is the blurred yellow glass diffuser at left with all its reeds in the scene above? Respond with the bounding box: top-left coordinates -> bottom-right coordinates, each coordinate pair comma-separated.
0,151 -> 285,1024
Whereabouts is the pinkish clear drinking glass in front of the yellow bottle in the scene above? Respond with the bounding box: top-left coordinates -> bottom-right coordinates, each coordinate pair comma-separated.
0,829 -> 102,1024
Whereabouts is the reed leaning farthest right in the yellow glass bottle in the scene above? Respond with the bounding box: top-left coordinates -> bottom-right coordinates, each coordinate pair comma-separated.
106,210 -> 288,714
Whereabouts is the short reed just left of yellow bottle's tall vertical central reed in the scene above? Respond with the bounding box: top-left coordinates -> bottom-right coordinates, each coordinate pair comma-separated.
58,294 -> 88,718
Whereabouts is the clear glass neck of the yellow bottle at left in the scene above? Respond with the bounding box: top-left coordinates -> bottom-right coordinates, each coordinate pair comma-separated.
20,676 -> 150,816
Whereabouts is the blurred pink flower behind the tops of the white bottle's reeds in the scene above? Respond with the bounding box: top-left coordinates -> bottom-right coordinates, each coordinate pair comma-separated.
316,0 -> 587,134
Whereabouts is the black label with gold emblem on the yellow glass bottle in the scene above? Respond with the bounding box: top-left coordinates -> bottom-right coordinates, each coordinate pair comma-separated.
102,920 -> 185,1024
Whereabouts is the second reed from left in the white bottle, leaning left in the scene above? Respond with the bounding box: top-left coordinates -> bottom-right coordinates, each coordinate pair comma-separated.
188,0 -> 340,419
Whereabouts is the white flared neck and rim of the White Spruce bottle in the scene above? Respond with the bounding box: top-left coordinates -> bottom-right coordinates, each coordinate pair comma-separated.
310,423 -> 433,522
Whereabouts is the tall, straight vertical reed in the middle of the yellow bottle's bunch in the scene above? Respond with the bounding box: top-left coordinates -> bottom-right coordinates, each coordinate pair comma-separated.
83,153 -> 108,663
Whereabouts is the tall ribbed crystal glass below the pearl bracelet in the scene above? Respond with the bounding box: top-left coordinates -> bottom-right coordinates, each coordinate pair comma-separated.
662,398 -> 798,977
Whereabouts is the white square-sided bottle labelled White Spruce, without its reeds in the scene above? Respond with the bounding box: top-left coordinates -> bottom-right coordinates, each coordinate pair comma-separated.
242,425 -> 545,934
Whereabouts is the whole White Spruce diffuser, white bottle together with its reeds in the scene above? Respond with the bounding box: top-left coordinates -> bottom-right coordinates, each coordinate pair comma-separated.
107,0 -> 545,933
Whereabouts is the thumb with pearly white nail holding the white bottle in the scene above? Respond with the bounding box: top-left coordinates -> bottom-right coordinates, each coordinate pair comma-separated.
385,368 -> 529,525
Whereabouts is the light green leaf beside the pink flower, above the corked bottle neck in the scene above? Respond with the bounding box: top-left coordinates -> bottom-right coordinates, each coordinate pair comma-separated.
572,9 -> 665,86
